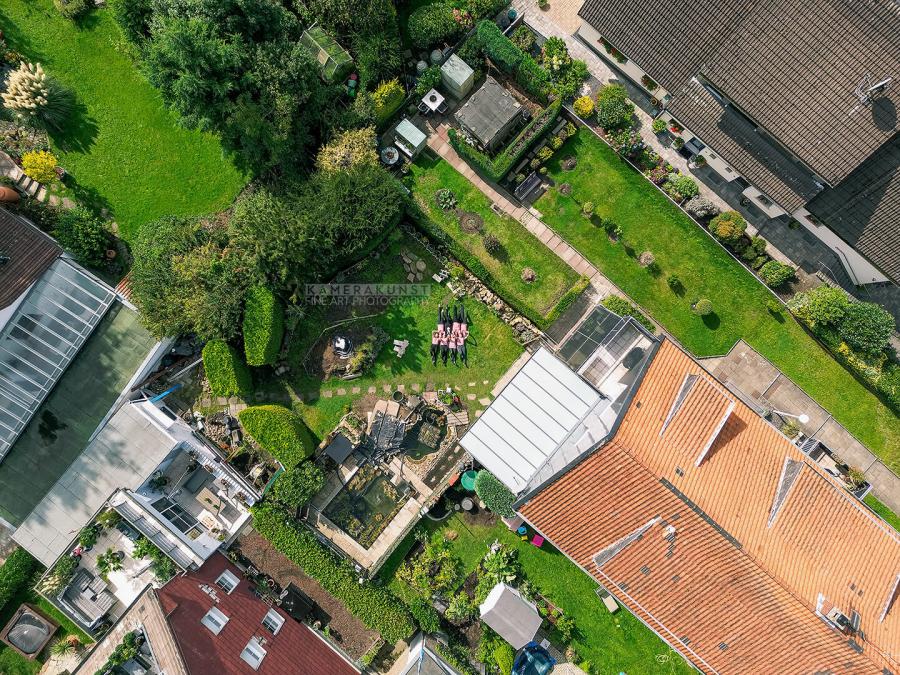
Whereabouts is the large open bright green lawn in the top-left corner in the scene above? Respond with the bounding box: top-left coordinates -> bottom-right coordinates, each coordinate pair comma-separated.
0,0 -> 246,239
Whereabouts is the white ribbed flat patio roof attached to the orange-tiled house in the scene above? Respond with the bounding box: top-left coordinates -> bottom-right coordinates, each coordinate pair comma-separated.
459,347 -> 609,494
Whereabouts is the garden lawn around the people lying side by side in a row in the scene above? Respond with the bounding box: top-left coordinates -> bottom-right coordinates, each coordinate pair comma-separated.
262,233 -> 522,437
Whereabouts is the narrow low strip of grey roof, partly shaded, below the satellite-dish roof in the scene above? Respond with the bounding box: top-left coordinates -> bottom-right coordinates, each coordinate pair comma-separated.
669,80 -> 822,211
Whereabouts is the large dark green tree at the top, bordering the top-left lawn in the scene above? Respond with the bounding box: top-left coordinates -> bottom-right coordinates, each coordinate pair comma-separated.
144,0 -> 331,174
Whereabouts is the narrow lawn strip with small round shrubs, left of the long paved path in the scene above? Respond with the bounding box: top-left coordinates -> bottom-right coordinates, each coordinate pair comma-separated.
410,157 -> 579,317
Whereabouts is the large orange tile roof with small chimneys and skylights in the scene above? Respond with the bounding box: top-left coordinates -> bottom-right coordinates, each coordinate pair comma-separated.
520,341 -> 900,673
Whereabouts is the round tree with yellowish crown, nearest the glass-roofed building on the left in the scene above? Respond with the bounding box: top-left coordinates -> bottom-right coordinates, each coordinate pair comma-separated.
131,217 -> 251,339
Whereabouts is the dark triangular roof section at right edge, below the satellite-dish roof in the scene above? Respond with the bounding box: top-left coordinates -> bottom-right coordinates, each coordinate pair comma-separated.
806,133 -> 900,283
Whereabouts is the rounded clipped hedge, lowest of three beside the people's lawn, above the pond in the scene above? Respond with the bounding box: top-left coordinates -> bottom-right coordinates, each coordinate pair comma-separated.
238,405 -> 316,469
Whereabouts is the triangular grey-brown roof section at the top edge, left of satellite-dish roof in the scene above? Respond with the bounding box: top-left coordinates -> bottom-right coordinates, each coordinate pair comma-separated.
578,0 -> 761,91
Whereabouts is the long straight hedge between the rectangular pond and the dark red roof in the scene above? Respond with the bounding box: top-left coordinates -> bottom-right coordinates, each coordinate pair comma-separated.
251,503 -> 416,644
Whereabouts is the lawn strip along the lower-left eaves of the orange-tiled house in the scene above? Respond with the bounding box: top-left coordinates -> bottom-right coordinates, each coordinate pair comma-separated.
379,515 -> 695,675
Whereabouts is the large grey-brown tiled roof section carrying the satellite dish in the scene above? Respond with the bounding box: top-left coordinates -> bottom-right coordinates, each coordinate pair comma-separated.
700,0 -> 900,185
